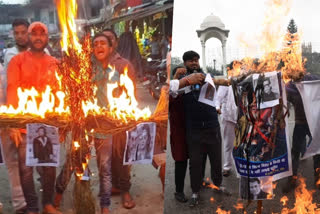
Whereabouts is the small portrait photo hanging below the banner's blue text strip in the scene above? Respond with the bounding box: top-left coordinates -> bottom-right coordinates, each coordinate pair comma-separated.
239,176 -> 273,200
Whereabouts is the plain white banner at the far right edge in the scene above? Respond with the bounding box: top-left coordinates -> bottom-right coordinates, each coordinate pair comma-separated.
296,80 -> 320,159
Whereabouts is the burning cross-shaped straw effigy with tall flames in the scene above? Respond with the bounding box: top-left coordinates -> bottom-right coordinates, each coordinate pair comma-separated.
0,0 -> 168,213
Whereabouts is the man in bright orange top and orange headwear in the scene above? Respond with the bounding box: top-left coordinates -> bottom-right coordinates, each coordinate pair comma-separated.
7,22 -> 61,214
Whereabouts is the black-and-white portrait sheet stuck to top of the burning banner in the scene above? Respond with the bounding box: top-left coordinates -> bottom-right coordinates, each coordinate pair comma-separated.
252,71 -> 280,109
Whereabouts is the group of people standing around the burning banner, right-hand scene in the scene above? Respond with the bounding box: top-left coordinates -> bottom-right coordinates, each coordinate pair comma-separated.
169,51 -> 320,207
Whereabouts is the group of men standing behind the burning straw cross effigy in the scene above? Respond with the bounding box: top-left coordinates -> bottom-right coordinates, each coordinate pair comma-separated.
0,19 -> 156,214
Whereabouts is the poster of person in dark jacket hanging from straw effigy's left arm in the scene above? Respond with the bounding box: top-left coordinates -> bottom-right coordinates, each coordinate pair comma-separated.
26,123 -> 60,167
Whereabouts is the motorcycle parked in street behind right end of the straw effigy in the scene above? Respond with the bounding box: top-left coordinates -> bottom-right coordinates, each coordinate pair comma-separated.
142,58 -> 167,99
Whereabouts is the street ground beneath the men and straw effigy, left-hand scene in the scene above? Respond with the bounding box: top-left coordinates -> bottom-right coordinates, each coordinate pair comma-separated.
0,85 -> 163,214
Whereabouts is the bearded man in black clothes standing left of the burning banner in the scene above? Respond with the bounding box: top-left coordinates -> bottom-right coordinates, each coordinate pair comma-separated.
172,51 -> 228,207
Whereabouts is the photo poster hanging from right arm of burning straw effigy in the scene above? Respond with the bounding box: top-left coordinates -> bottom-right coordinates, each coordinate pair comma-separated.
123,122 -> 156,165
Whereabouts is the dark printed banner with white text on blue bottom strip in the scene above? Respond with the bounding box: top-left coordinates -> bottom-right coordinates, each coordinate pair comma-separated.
233,72 -> 292,180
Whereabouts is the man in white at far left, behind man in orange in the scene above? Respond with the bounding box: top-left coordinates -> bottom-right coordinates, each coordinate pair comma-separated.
0,19 -> 29,214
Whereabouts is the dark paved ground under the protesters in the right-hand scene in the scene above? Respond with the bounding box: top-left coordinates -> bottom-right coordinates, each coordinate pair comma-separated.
164,109 -> 320,214
